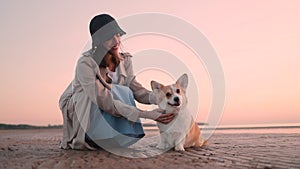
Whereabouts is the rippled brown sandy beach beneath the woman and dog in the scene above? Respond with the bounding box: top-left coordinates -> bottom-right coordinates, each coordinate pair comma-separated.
0,129 -> 300,169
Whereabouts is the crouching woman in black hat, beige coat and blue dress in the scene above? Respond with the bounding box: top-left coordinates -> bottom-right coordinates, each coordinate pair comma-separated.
59,14 -> 174,149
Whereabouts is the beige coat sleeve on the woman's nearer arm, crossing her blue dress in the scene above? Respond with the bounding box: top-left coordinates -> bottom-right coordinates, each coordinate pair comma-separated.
76,58 -> 141,121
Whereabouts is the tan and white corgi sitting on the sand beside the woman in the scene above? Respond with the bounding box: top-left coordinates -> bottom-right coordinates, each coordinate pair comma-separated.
151,74 -> 205,151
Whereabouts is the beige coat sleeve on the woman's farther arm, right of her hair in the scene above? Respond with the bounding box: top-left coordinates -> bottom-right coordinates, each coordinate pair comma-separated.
124,53 -> 156,104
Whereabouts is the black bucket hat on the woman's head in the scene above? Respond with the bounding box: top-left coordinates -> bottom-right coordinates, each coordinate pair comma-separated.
90,14 -> 126,46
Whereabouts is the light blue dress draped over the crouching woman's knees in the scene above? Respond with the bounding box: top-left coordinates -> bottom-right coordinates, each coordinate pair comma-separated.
86,85 -> 145,148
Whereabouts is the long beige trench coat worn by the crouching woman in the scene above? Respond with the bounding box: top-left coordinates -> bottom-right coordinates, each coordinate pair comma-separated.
59,51 -> 155,149
